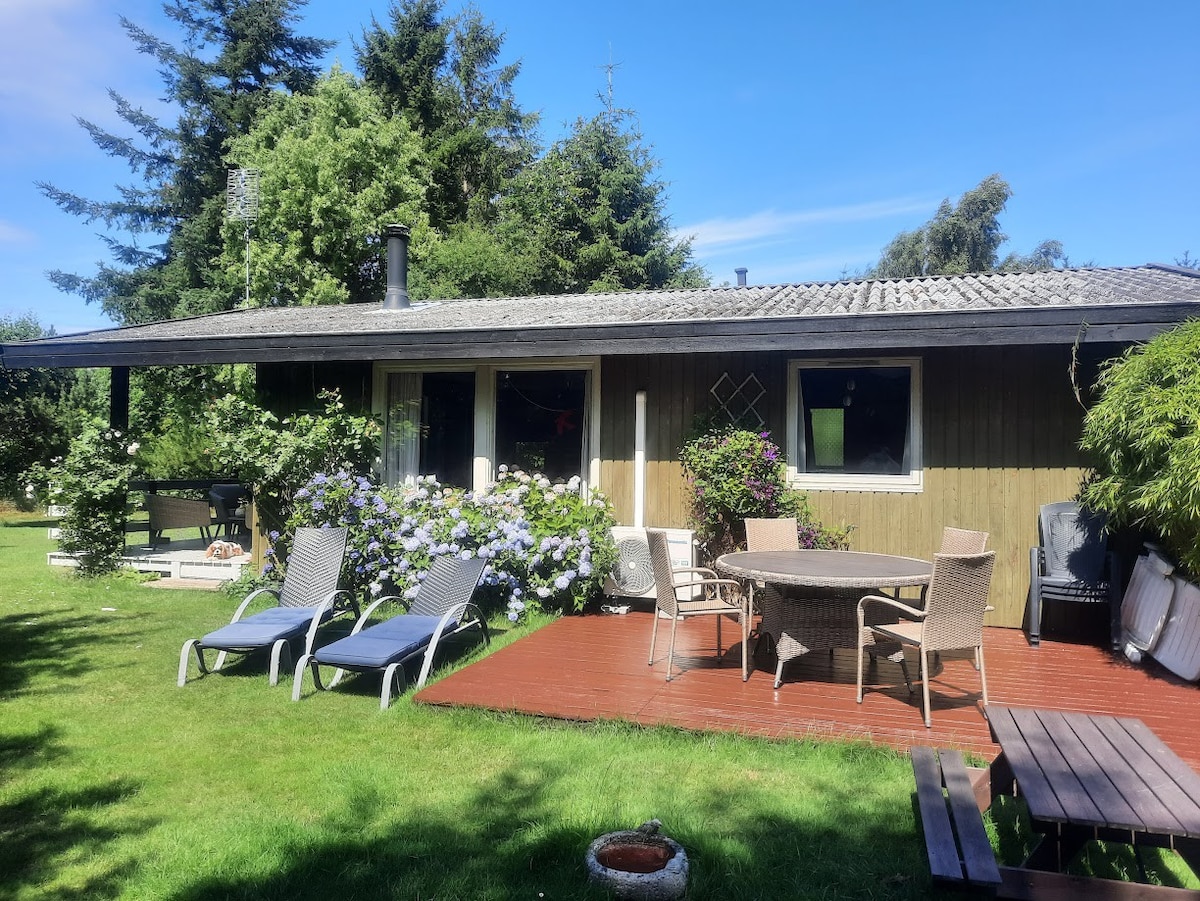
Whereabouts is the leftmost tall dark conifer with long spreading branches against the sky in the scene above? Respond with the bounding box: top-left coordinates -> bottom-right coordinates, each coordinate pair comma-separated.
38,0 -> 332,324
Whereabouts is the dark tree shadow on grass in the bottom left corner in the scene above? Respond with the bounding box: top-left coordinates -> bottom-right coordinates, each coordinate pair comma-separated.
0,728 -> 148,899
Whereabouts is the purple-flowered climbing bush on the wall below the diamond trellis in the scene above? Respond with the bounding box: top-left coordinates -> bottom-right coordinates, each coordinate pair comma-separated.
679,427 -> 852,559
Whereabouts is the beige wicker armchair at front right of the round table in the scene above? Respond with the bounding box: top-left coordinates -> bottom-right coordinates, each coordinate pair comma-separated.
858,551 -> 996,727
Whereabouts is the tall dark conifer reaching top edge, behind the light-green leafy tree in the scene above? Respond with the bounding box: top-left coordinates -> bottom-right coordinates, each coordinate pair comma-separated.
355,0 -> 538,232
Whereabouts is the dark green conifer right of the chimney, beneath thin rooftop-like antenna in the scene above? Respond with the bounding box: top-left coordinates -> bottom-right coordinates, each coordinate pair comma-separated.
499,110 -> 708,294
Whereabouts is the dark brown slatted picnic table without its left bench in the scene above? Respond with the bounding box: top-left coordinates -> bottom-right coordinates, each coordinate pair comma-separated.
988,704 -> 1200,899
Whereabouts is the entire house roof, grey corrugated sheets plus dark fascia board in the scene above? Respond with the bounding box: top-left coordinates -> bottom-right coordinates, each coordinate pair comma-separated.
9,265 -> 1200,366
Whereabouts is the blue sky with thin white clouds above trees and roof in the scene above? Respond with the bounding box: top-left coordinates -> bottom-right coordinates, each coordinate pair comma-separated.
0,0 -> 1200,334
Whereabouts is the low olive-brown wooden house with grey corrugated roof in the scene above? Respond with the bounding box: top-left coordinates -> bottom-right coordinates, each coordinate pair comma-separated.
0,254 -> 1200,627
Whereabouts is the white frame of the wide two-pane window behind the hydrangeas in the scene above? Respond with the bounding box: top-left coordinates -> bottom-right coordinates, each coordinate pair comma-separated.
371,356 -> 600,494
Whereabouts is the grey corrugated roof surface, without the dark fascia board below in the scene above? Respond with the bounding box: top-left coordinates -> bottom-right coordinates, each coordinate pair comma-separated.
32,266 -> 1200,342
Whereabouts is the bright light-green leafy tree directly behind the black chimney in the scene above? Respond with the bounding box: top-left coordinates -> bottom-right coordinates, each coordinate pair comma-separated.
224,70 -> 434,306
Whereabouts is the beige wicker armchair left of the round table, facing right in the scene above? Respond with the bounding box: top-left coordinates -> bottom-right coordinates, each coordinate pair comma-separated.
646,529 -> 749,681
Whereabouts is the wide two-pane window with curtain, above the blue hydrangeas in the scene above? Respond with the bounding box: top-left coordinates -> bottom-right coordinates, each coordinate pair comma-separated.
376,359 -> 600,489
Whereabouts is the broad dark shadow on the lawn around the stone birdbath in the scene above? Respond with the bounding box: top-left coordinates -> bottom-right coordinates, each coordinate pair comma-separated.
164,761 -> 929,901
